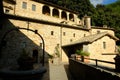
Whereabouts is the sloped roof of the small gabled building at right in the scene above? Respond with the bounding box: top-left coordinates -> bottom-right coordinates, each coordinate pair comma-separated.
63,32 -> 119,47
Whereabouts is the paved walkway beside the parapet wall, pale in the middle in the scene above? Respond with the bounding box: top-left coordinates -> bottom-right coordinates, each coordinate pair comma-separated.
43,62 -> 73,80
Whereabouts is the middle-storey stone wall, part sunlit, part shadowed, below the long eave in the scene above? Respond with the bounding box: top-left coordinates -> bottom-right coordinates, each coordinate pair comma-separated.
0,17 -> 89,67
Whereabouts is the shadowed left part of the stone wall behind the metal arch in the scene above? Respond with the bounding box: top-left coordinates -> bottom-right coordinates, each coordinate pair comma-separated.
0,19 -> 42,67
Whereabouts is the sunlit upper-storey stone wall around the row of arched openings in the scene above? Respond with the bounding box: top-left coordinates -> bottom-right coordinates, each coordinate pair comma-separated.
4,0 -> 82,25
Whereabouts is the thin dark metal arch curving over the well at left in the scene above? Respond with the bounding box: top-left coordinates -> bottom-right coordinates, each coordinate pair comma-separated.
0,27 -> 45,66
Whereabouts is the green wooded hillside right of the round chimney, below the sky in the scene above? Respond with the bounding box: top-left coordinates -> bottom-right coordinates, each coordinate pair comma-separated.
92,0 -> 120,38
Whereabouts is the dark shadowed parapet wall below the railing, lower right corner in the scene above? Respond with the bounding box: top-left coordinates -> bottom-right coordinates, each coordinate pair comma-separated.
69,59 -> 120,80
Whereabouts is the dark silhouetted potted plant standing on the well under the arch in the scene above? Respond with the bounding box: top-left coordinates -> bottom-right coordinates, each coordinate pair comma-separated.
17,49 -> 35,70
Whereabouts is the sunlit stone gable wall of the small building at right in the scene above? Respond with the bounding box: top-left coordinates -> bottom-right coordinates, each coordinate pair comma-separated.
88,36 -> 116,68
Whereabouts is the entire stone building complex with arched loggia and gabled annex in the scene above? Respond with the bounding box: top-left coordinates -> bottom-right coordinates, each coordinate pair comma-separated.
0,0 -> 119,67
